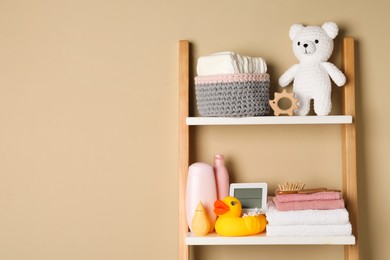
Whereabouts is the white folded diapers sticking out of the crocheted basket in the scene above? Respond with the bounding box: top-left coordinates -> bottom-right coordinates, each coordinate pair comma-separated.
196,52 -> 267,76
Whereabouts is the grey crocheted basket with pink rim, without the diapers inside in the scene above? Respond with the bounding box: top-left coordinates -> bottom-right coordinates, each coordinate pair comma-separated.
195,73 -> 270,117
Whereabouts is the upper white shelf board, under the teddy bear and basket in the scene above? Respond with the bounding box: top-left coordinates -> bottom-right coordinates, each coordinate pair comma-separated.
186,115 -> 353,125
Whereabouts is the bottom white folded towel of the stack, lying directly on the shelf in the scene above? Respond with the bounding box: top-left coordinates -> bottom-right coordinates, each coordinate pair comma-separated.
266,223 -> 352,236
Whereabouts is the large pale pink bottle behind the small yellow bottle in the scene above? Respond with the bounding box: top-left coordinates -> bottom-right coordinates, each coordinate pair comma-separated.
186,162 -> 217,232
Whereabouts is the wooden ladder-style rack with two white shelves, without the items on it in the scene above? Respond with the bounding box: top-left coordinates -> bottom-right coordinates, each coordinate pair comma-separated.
179,37 -> 359,260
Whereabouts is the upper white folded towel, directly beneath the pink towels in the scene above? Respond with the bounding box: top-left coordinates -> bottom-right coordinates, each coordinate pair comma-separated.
266,201 -> 349,226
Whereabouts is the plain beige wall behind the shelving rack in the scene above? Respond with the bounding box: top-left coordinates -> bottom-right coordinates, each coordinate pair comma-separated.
0,0 -> 390,260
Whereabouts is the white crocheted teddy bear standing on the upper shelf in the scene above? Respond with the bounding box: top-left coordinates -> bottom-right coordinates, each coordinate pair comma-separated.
279,22 -> 346,116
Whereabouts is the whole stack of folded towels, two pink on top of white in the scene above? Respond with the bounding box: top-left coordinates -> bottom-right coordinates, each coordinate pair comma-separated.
266,191 -> 352,236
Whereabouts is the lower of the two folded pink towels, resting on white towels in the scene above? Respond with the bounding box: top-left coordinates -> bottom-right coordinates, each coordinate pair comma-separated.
273,197 -> 345,211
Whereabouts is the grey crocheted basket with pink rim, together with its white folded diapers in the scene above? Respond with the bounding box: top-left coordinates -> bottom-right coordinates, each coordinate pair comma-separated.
195,52 -> 270,117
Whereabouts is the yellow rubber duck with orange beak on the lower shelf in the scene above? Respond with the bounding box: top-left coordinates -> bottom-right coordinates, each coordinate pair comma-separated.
214,196 -> 267,236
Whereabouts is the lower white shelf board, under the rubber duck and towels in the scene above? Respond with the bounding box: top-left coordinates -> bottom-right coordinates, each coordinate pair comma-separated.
186,232 -> 355,246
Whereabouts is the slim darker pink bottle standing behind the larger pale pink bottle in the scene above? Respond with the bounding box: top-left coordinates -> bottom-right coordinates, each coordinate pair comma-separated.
214,154 -> 229,200
